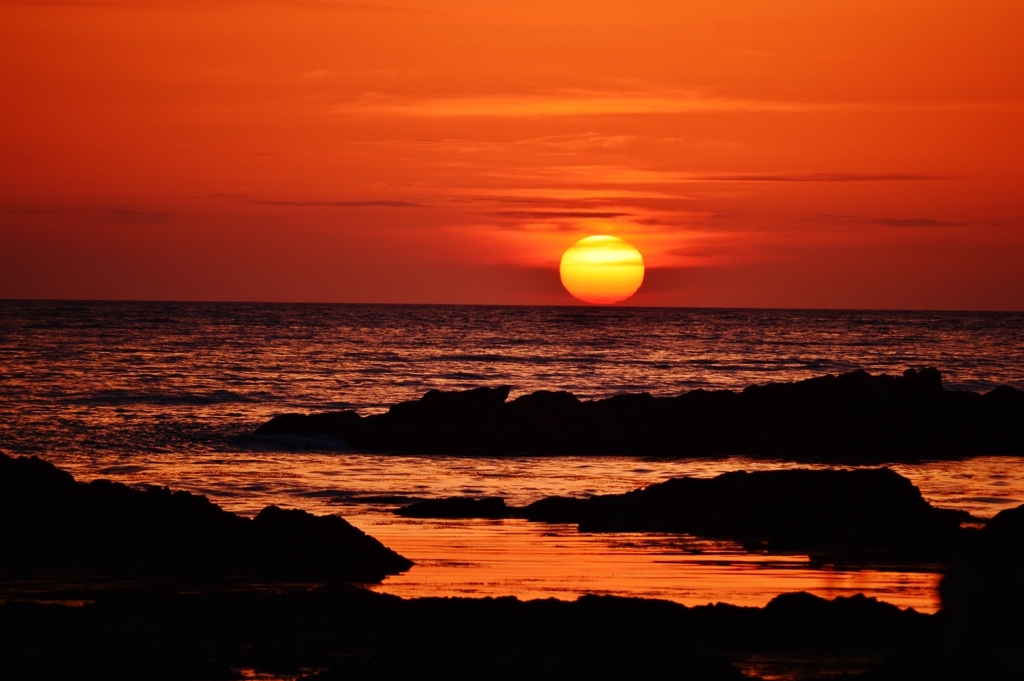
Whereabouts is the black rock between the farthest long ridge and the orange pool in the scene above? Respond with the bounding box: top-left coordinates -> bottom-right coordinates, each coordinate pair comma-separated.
395,468 -> 972,561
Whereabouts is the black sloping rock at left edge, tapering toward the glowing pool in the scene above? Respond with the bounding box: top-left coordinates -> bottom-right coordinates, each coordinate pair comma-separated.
0,454 -> 412,582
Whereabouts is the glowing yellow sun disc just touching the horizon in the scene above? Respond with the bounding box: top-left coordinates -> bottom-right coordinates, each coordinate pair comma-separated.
558,235 -> 644,305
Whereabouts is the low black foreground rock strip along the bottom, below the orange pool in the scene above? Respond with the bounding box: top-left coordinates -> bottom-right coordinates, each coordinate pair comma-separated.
0,587 -> 941,681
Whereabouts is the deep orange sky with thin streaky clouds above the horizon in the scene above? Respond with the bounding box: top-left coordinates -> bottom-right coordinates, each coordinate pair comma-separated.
0,0 -> 1024,310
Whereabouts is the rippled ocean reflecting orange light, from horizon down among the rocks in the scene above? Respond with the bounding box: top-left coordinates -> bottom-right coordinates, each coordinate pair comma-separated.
0,301 -> 1024,611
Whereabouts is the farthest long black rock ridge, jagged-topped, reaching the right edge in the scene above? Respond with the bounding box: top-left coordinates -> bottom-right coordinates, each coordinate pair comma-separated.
256,369 -> 1024,462
